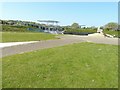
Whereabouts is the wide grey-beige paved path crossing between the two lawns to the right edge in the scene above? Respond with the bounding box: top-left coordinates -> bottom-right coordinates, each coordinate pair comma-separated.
0,35 -> 118,57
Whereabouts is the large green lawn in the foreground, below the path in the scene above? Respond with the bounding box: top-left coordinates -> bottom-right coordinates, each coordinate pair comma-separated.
2,43 -> 118,88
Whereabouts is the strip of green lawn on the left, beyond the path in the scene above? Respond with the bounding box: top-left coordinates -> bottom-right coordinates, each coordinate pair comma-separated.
0,32 -> 56,42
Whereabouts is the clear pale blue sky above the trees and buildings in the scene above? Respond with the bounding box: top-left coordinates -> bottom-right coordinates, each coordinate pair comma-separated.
0,2 -> 118,26
